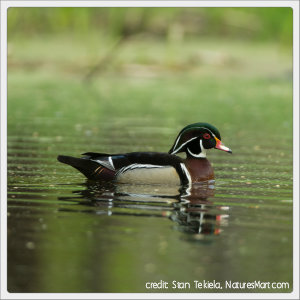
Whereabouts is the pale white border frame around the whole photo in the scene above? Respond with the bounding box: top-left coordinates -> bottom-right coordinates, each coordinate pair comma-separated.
0,0 -> 299,299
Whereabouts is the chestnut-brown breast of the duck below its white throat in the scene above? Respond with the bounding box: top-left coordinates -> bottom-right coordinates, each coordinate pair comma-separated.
185,157 -> 215,182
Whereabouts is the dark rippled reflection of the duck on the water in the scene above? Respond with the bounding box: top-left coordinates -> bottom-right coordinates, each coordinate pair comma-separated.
59,181 -> 229,238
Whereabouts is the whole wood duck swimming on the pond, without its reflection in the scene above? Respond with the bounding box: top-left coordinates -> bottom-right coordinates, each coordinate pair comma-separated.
57,123 -> 232,185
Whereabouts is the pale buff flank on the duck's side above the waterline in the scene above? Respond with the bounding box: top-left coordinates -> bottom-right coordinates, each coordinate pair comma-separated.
117,166 -> 180,185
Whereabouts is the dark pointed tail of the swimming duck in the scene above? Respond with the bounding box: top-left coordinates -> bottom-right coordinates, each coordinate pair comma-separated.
57,155 -> 99,179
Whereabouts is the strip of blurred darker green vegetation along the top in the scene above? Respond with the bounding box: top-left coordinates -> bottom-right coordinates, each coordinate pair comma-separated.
8,7 -> 293,46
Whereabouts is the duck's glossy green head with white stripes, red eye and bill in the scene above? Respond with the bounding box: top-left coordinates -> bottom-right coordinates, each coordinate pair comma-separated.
169,123 -> 232,158
